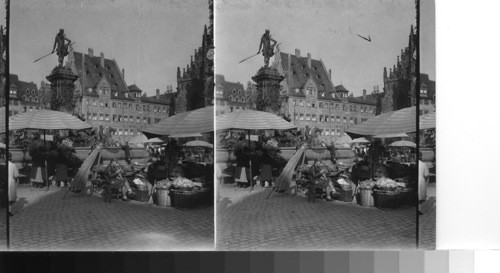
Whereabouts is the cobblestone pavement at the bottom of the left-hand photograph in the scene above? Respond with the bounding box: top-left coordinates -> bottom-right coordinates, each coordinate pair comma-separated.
10,187 -> 214,251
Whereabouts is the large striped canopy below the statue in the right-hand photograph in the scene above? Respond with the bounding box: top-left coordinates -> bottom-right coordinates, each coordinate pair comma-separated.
216,110 -> 297,130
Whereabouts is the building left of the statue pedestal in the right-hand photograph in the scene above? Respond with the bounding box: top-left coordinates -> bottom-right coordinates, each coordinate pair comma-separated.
215,75 -> 248,115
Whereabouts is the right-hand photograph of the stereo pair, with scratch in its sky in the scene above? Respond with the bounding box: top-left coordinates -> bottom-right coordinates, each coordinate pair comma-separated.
215,0 -> 435,250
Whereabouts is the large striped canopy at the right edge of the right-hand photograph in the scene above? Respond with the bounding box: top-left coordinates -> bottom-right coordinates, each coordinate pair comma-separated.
346,106 -> 416,138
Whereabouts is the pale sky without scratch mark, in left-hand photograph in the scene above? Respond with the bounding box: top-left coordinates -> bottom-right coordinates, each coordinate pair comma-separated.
10,0 -> 209,95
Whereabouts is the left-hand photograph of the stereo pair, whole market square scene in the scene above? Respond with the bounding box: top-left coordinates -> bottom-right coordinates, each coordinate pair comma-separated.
6,0 -> 214,251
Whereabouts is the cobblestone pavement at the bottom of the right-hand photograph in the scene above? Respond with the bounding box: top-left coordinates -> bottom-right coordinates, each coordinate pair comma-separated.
216,182 -> 435,250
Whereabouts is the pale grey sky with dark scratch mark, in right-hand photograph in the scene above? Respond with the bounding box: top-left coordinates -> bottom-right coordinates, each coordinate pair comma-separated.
216,0 -> 433,95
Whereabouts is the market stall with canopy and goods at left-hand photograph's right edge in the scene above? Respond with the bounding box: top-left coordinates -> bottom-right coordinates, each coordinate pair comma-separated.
142,107 -> 214,208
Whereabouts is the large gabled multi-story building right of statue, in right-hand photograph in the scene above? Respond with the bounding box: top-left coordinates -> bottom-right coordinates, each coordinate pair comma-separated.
273,49 -> 376,142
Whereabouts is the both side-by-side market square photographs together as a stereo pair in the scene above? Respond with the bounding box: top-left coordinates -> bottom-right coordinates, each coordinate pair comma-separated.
0,0 -> 436,251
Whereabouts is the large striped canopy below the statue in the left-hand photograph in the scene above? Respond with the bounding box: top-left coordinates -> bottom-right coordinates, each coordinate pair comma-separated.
9,110 -> 92,130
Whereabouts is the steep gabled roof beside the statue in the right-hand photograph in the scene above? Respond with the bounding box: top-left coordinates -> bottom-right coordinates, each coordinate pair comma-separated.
280,52 -> 335,96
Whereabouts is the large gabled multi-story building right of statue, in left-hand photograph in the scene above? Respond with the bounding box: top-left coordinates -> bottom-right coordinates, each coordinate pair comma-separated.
67,49 -> 173,142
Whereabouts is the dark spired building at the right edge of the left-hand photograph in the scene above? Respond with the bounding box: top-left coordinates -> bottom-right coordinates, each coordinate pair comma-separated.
175,0 -> 214,113
